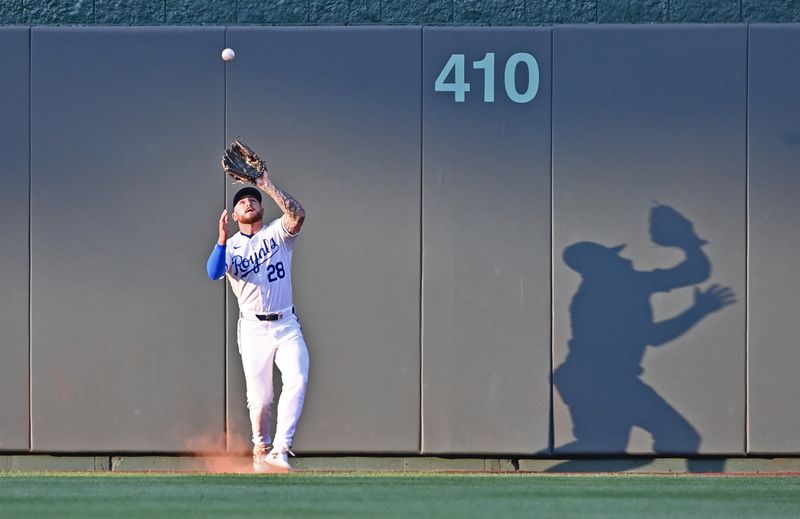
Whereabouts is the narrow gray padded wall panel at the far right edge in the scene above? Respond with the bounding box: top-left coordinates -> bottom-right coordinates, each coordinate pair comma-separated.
748,25 -> 800,454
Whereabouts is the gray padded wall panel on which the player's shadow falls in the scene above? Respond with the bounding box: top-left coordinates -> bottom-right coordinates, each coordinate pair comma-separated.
553,26 -> 747,454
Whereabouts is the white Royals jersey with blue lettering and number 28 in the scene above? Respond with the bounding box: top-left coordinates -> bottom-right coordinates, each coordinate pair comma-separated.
225,218 -> 297,315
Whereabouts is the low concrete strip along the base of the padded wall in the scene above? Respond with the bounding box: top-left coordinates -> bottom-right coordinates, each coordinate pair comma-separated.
0,455 -> 800,475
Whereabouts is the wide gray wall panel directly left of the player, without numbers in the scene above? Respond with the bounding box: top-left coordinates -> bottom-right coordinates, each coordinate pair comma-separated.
31,27 -> 225,451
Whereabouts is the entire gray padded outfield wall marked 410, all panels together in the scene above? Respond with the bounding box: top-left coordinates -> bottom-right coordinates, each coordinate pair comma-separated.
0,25 -> 800,458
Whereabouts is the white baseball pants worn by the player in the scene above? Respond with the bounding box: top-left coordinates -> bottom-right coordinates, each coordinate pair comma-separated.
238,314 -> 308,447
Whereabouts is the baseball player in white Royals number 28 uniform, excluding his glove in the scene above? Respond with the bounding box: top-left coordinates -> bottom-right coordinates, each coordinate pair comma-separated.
208,171 -> 308,472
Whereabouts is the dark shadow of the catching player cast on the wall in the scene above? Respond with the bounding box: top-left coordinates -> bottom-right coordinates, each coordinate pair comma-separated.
551,206 -> 735,472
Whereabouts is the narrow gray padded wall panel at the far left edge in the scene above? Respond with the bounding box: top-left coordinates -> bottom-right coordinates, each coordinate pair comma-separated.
0,27 -> 30,450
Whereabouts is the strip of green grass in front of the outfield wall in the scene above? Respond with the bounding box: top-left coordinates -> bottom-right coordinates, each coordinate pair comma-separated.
0,473 -> 800,519
